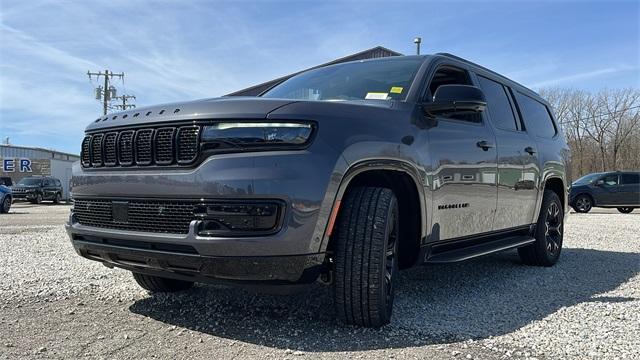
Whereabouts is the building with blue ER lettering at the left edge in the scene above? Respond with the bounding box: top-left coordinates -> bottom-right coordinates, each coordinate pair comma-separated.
0,144 -> 80,199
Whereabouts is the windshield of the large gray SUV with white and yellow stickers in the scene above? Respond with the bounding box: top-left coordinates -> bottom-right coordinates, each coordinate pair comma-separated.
262,57 -> 423,101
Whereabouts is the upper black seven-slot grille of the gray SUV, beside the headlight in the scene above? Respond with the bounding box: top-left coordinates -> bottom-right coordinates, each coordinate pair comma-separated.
81,125 -> 200,168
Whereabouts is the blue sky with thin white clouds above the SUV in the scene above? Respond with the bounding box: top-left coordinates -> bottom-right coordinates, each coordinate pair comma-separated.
0,0 -> 640,153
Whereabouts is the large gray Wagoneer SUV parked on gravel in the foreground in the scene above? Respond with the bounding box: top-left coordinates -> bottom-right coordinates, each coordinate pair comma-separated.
66,54 -> 569,326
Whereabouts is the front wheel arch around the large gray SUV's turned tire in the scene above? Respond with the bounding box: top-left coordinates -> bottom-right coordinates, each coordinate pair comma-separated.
322,160 -> 427,268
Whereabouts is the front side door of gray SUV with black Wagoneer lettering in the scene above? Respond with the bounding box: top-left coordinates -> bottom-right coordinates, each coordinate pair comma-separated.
426,66 -> 497,241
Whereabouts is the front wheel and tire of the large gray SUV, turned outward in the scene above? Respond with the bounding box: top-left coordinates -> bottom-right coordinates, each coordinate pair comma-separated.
334,187 -> 399,327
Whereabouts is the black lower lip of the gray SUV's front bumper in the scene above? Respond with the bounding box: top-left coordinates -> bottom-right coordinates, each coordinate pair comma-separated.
67,231 -> 324,285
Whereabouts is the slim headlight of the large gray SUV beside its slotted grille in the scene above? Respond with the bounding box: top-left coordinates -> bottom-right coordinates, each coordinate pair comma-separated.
202,122 -> 314,151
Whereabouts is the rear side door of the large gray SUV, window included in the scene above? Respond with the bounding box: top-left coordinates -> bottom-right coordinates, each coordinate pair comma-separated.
477,75 -> 539,230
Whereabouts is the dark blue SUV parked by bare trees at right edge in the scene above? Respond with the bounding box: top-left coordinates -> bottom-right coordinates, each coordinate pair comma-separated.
569,171 -> 640,214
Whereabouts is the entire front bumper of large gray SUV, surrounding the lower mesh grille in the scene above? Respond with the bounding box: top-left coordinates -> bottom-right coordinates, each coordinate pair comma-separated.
66,146 -> 344,284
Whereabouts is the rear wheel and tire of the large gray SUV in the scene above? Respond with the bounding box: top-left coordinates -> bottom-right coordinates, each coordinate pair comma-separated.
518,190 -> 564,266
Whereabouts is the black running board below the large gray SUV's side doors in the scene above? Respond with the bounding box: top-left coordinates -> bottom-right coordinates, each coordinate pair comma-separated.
425,236 -> 536,264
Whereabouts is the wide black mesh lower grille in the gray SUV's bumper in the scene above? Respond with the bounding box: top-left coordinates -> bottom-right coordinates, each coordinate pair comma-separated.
73,199 -> 196,234
